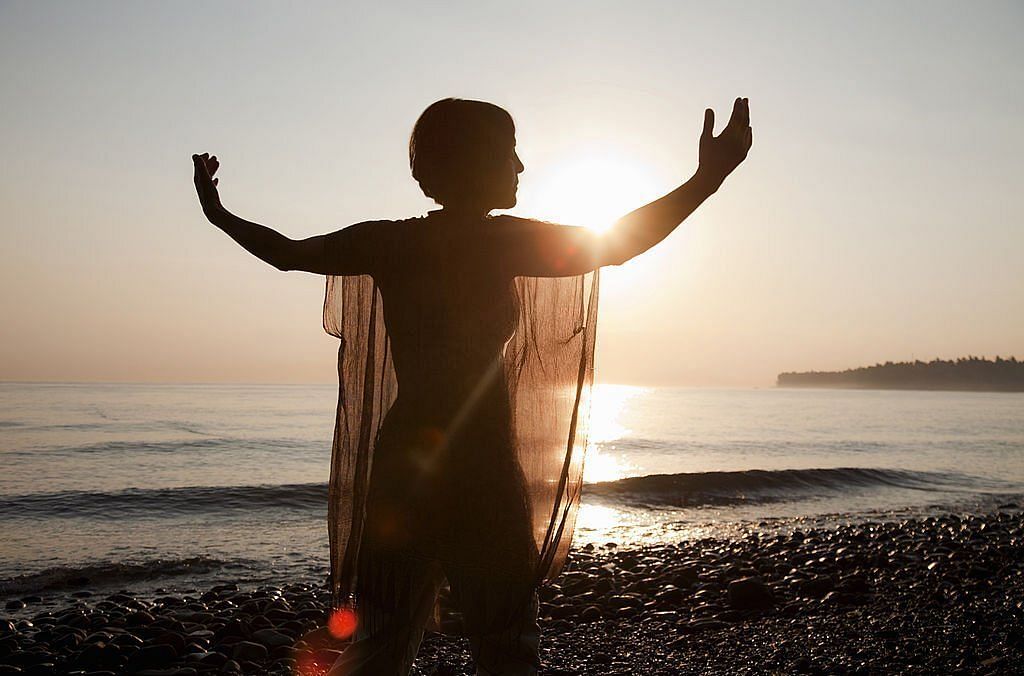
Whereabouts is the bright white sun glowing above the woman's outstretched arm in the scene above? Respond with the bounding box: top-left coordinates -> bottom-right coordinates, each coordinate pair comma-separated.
524,147 -> 655,233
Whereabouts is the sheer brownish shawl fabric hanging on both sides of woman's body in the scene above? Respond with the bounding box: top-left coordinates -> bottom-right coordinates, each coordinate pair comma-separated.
324,233 -> 598,629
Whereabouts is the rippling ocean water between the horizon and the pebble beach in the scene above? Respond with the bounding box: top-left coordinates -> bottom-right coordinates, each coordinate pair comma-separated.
0,383 -> 1024,598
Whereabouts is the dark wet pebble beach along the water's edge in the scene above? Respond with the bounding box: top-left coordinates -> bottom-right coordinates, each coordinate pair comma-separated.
0,505 -> 1024,676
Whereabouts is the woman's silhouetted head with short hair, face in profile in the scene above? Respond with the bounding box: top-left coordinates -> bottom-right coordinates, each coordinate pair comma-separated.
409,98 -> 523,211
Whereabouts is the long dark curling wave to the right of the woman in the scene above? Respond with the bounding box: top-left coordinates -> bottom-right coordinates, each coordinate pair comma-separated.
584,467 -> 982,507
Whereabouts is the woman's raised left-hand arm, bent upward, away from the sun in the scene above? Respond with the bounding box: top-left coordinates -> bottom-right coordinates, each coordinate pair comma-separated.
193,153 -> 374,274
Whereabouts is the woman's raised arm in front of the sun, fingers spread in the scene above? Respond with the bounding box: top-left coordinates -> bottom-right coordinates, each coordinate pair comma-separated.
511,98 -> 753,277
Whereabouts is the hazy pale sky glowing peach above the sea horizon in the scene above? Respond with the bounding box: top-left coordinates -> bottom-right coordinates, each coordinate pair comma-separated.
0,0 -> 1024,385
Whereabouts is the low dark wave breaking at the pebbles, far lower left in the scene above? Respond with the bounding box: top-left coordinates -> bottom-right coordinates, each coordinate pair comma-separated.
0,556 -> 231,596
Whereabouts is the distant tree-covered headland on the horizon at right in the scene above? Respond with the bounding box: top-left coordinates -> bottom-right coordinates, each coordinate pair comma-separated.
777,356 -> 1024,392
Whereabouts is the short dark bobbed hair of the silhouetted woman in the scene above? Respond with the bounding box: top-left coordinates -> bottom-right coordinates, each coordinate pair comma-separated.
409,98 -> 515,205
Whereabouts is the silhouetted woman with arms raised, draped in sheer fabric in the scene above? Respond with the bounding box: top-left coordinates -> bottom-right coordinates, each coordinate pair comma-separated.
193,98 -> 752,675
